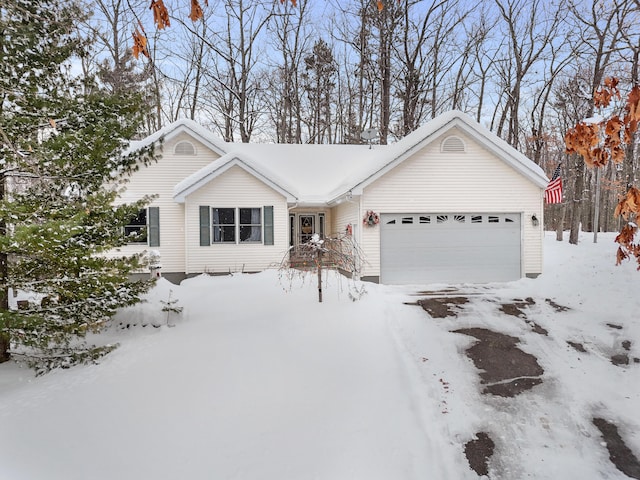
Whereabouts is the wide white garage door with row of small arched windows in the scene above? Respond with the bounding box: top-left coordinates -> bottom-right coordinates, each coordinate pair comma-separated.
380,213 -> 521,284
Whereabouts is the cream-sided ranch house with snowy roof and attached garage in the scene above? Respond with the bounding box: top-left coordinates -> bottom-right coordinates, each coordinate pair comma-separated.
120,111 -> 548,284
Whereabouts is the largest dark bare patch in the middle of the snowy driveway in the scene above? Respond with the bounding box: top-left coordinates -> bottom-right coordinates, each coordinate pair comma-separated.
454,328 -> 544,397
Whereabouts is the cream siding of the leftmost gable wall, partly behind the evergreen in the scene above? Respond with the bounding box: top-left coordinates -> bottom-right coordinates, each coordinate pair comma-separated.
114,134 -> 219,273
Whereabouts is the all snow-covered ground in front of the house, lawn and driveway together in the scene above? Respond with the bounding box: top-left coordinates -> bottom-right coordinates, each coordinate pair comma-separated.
0,233 -> 640,480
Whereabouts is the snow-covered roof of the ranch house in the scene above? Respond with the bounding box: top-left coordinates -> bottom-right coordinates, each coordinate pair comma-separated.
136,111 -> 548,205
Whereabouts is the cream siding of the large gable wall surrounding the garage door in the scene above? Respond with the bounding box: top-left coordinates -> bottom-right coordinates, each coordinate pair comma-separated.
361,129 -> 543,282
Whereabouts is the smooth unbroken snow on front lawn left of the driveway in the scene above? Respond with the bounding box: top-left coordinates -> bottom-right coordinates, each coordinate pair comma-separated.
0,272 -> 468,480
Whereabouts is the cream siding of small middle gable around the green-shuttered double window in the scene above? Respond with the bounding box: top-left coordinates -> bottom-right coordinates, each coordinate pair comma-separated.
184,166 -> 289,273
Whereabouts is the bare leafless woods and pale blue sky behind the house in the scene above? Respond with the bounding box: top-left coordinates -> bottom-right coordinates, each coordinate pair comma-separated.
81,0 -> 640,239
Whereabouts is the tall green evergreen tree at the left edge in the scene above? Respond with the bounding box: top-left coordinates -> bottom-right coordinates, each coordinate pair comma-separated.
0,0 -> 154,367
